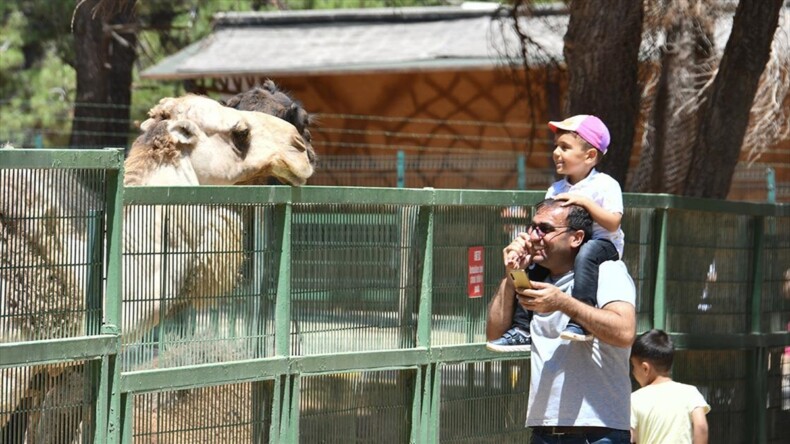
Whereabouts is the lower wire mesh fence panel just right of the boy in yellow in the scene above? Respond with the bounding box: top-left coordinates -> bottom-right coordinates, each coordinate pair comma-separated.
672,350 -> 752,443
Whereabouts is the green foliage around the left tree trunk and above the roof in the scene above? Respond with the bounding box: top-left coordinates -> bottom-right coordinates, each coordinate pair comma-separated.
0,0 -> 464,147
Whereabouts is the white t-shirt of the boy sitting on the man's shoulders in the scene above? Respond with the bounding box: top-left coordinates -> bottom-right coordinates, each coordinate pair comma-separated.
546,168 -> 625,259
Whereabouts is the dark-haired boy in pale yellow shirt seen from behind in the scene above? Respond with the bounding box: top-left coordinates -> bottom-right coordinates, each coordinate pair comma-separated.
631,330 -> 710,444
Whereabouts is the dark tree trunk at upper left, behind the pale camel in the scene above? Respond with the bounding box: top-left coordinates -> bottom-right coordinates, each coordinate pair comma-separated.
69,0 -> 136,148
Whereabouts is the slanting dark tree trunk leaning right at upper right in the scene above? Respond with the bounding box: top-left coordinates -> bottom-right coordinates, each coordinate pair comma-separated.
684,0 -> 783,199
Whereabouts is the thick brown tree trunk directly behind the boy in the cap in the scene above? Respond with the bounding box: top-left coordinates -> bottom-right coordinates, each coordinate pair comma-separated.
564,0 -> 643,187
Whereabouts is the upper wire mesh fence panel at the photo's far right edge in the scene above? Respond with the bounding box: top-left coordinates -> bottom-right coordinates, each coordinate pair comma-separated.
760,217 -> 790,332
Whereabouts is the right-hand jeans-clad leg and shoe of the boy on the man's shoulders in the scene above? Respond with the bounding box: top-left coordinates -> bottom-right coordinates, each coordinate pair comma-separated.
563,239 -> 620,340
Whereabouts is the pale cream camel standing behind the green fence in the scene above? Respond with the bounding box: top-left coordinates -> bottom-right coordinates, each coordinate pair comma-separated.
0,95 -> 313,442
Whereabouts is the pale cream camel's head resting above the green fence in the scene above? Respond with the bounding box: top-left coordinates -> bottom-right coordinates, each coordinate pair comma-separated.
125,95 -> 313,185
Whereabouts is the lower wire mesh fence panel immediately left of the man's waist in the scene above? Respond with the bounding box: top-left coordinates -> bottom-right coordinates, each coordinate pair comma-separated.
439,360 -> 530,444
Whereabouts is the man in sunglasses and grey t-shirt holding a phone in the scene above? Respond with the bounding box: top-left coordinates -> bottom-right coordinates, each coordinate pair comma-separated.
486,199 -> 636,444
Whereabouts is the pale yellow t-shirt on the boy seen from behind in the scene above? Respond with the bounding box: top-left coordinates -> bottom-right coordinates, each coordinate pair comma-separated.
631,381 -> 710,444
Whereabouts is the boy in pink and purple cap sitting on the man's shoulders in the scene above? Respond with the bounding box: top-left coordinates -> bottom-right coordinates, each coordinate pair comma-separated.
486,114 -> 625,352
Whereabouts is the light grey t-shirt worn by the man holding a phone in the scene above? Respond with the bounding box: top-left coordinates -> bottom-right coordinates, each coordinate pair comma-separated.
527,261 -> 636,430
